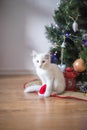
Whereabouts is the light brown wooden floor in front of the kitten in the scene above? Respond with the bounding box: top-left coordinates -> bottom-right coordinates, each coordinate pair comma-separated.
0,75 -> 87,130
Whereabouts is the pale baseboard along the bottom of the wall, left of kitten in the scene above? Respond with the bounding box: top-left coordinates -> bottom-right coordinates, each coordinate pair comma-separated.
0,69 -> 36,75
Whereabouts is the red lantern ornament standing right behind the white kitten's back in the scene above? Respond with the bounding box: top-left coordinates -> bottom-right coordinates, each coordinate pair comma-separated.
64,67 -> 77,91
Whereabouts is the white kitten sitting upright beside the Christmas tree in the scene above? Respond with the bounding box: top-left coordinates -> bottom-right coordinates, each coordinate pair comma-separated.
25,51 -> 65,97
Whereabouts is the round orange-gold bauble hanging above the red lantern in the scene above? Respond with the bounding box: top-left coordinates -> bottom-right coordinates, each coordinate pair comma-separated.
73,58 -> 86,72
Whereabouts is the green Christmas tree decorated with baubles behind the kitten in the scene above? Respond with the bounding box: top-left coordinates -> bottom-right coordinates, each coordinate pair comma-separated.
45,0 -> 87,82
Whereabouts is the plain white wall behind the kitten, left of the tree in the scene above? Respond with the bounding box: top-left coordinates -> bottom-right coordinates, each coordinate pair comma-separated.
0,0 -> 57,74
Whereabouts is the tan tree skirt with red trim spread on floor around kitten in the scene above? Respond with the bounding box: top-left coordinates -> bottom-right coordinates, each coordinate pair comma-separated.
23,79 -> 87,101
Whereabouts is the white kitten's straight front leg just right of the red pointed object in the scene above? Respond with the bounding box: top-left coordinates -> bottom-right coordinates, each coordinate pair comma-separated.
44,80 -> 53,97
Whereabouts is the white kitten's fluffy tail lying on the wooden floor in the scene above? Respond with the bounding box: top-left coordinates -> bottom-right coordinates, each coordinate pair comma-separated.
24,84 -> 41,93
